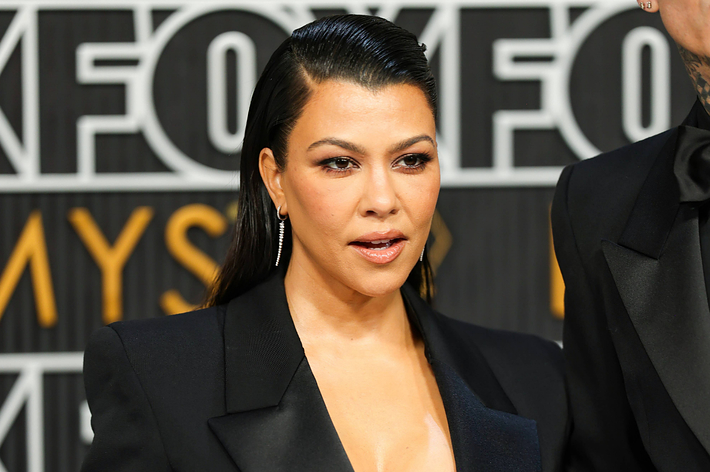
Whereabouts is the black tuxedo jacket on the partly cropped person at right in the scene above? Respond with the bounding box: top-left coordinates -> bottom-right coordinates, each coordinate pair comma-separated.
552,100 -> 710,472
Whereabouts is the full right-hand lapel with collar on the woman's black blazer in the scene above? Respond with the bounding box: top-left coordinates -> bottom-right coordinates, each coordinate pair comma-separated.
402,285 -> 542,472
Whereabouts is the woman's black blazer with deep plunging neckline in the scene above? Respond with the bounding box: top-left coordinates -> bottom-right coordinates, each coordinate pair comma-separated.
82,275 -> 567,472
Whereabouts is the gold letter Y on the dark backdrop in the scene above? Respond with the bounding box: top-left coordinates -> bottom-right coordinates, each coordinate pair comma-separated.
69,207 -> 153,324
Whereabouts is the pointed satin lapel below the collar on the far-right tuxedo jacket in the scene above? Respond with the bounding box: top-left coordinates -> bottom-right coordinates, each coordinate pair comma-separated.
602,205 -> 710,452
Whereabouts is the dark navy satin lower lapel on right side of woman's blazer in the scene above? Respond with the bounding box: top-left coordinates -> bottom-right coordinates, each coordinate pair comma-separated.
431,360 -> 542,472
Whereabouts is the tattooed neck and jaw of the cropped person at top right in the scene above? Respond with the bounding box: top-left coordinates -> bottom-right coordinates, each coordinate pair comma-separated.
646,0 -> 710,113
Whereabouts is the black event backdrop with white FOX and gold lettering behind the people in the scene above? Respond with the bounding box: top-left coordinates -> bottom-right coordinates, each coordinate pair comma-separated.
0,0 -> 694,472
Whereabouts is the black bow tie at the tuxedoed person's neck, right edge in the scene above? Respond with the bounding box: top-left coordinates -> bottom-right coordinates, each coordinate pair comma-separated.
673,126 -> 710,202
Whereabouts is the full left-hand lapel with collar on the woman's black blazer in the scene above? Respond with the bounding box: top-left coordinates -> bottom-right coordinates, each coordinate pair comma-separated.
208,275 -> 352,472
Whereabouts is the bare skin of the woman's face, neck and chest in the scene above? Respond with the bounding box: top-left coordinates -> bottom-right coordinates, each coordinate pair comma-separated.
260,81 -> 455,472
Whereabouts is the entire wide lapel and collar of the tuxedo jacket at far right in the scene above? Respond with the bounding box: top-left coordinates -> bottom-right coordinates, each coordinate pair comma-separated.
602,117 -> 710,451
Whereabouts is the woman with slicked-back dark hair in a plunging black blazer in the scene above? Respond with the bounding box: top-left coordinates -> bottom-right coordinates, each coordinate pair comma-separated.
83,15 -> 566,472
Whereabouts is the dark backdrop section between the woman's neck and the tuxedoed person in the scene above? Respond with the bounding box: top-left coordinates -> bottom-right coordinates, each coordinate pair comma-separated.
436,188 -> 562,339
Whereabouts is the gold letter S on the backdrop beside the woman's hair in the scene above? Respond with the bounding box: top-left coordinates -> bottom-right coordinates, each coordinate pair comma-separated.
160,203 -> 227,315
